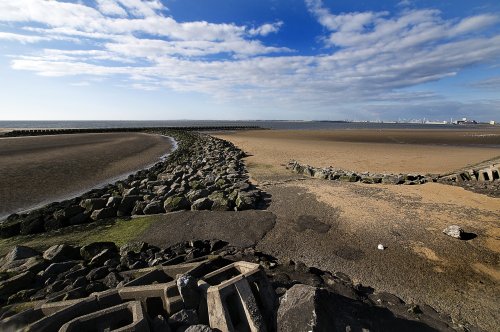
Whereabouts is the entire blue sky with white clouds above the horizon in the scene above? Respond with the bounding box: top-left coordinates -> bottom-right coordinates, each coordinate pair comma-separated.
0,0 -> 500,121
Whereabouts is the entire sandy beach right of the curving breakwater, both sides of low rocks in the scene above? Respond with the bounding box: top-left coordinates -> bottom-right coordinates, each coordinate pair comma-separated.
218,131 -> 500,331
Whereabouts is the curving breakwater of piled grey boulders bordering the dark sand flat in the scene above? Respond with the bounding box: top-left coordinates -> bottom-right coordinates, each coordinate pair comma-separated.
0,130 -> 262,238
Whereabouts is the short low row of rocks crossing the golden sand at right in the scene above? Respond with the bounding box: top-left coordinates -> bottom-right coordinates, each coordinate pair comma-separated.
286,160 -> 437,185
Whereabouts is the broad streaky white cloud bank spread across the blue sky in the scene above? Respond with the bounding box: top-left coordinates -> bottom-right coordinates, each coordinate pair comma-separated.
0,0 -> 500,118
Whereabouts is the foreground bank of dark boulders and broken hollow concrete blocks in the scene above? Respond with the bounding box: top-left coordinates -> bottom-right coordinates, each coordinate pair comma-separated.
0,240 -> 464,332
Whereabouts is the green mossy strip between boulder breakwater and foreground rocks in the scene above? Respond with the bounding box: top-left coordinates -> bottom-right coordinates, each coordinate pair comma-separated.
0,216 -> 155,255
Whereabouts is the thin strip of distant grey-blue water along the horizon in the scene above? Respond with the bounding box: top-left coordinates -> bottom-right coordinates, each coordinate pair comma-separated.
0,120 -> 488,130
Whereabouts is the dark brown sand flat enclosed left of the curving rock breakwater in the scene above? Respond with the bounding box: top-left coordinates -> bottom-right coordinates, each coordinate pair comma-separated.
0,133 -> 172,217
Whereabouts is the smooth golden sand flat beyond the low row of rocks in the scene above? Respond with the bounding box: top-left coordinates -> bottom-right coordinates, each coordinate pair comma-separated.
218,128 -> 500,174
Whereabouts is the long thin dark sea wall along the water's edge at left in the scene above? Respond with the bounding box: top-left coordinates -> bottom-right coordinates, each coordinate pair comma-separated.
0,126 -> 265,137
